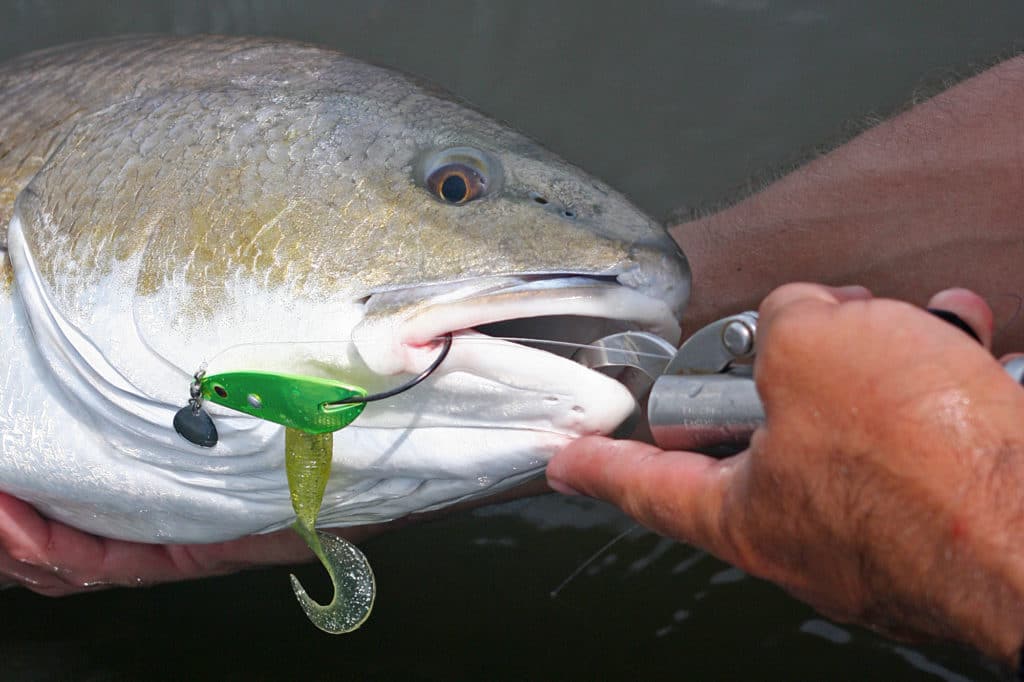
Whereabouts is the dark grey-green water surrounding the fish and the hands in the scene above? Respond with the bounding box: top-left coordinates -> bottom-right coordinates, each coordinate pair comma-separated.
0,0 -> 1024,680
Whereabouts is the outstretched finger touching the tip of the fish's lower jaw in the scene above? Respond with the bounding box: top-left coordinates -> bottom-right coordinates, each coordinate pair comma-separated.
548,436 -> 745,559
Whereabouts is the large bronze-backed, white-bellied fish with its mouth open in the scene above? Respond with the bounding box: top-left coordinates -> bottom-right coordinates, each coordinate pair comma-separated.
0,37 -> 689,542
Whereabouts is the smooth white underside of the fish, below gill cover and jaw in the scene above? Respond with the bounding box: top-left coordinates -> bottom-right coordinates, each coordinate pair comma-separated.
0,282 -> 567,543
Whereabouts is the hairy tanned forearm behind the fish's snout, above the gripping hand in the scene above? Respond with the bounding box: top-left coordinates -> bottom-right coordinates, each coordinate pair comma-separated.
672,57 -> 1024,352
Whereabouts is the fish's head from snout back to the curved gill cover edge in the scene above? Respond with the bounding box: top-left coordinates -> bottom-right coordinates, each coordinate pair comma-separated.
12,45 -> 689,523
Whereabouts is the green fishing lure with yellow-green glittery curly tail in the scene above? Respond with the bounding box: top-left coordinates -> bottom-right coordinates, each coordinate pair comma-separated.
201,372 -> 376,634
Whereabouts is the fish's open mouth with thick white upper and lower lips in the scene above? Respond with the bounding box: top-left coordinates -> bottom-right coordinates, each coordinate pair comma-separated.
353,273 -> 680,437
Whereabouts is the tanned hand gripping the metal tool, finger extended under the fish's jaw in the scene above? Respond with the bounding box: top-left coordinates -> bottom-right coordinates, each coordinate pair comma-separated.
548,285 -> 1024,662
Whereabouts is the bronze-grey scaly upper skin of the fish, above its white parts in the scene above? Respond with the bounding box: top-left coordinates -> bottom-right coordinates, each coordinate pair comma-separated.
0,38 -> 678,303
